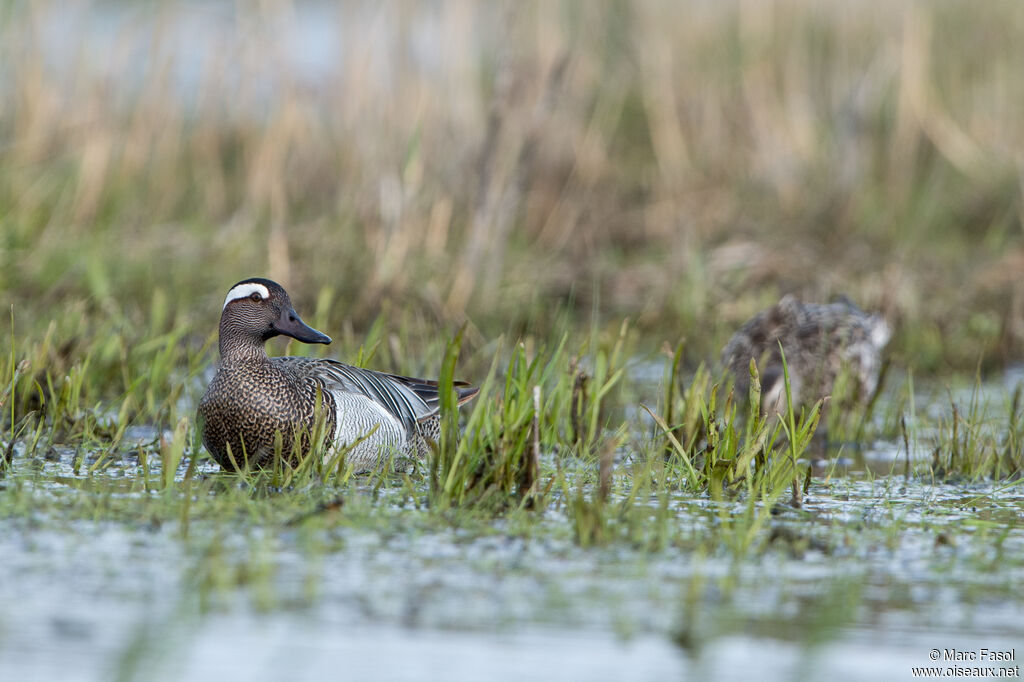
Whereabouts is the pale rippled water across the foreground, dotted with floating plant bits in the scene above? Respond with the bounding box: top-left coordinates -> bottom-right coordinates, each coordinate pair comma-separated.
0,444 -> 1024,680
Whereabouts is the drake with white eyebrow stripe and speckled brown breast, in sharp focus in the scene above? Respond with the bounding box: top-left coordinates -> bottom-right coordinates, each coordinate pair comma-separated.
199,278 -> 478,471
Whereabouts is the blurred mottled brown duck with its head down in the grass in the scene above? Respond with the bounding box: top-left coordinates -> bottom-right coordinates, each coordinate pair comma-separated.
722,295 -> 892,414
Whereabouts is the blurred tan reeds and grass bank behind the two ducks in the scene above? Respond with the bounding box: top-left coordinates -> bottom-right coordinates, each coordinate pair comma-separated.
0,0 -> 1024,372
